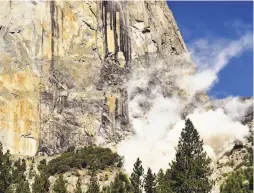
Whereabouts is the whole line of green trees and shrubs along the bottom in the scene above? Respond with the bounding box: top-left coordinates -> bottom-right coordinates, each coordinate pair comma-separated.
0,119 -> 253,193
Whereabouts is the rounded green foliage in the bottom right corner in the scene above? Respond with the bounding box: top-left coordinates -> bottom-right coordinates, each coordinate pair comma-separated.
220,167 -> 253,193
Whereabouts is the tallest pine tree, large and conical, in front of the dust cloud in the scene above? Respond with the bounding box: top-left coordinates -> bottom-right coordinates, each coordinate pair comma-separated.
170,119 -> 213,193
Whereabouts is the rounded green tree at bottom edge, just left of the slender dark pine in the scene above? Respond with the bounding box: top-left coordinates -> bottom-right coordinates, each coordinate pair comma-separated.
103,172 -> 131,193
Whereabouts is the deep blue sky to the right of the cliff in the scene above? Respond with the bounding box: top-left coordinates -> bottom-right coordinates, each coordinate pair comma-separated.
168,1 -> 253,98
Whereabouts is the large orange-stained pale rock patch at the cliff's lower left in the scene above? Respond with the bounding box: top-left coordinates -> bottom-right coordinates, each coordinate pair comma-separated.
0,69 -> 40,155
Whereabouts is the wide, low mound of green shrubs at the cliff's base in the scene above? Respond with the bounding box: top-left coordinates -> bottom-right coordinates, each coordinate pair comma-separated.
47,146 -> 122,175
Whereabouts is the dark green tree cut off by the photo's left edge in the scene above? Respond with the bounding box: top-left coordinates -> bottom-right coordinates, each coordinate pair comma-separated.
0,142 -> 12,193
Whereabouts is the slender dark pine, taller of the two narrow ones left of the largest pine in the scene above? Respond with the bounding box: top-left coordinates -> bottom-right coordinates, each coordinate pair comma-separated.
130,158 -> 144,193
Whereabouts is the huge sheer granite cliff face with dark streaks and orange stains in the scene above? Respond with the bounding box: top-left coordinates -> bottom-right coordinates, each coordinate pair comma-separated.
0,1 -> 195,155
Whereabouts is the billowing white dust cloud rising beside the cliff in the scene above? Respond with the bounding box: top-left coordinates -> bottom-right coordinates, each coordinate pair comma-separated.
118,34 -> 252,173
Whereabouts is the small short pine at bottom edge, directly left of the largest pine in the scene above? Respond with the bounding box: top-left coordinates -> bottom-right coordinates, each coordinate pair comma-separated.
156,169 -> 172,193
